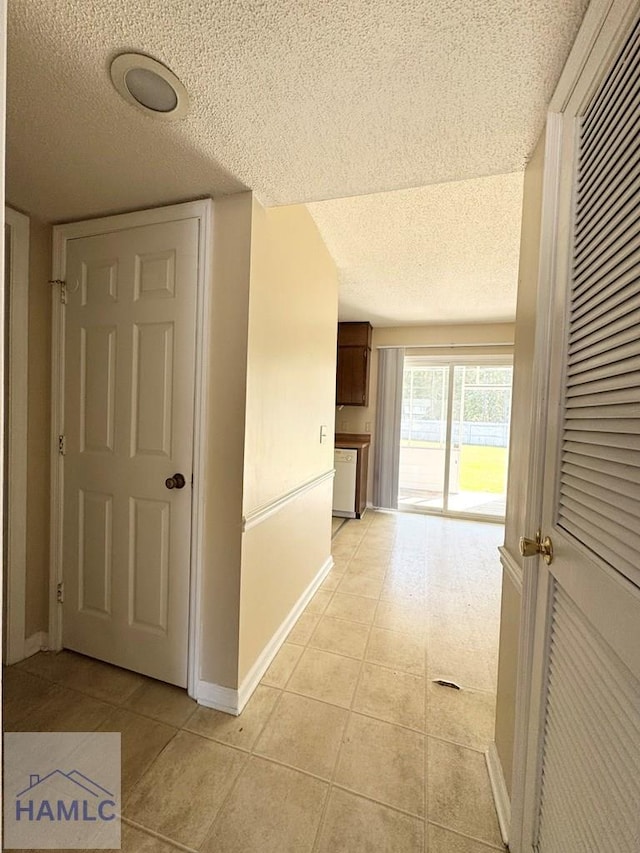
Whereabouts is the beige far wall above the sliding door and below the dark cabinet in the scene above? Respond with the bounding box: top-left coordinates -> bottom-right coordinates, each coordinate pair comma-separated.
336,323 -> 514,502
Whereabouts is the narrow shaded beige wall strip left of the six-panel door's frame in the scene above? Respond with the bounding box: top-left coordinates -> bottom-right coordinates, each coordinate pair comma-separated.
25,218 -> 52,637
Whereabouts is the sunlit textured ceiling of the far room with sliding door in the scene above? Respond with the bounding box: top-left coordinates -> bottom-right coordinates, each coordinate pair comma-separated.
308,172 -> 523,326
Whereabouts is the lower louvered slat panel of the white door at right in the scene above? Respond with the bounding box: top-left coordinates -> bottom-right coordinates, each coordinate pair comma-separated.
538,587 -> 640,853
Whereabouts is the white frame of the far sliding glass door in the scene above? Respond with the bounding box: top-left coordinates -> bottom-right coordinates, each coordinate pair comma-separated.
398,353 -> 513,524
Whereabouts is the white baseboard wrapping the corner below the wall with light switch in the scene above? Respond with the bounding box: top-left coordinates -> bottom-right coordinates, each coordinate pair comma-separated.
194,556 -> 333,716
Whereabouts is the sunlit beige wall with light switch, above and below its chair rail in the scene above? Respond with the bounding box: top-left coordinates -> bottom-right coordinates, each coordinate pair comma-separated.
239,201 -> 338,681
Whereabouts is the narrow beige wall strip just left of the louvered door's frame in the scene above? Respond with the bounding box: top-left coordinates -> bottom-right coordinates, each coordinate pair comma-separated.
495,134 -> 544,793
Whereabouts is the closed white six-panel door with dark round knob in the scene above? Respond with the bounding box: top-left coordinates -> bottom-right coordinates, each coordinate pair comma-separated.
62,219 -> 199,686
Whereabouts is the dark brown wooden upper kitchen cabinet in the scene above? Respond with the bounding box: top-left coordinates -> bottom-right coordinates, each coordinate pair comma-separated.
336,323 -> 373,406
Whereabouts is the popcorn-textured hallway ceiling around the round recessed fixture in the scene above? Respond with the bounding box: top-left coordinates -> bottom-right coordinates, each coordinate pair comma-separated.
7,0 -> 587,225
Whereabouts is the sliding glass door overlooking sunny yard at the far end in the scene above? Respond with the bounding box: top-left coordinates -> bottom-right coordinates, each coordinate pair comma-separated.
398,356 -> 513,519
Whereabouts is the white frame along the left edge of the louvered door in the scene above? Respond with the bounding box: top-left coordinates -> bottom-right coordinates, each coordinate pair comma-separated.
509,0 -> 640,853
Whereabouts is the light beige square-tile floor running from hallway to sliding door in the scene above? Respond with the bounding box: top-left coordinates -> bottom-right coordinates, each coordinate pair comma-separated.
4,512 -> 503,853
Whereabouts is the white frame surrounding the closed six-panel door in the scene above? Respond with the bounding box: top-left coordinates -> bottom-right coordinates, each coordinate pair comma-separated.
49,199 -> 213,696
